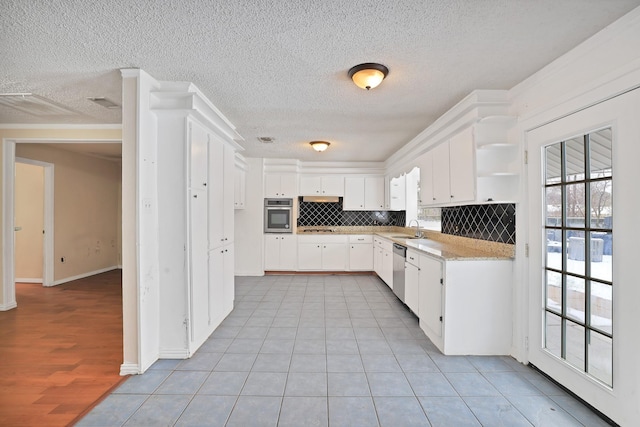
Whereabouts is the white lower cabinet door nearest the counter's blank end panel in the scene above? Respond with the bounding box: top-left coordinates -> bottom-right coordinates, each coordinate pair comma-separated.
419,255 -> 443,337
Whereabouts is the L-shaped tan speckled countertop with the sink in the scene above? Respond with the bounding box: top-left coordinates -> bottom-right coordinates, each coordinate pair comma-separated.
297,227 -> 515,261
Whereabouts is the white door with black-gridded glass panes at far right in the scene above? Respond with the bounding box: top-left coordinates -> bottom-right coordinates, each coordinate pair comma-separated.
526,89 -> 640,425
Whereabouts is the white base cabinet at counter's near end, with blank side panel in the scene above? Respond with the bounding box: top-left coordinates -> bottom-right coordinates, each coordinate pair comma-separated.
419,255 -> 513,355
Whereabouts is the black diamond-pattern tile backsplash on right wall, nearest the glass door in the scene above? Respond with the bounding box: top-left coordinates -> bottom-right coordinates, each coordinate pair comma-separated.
442,203 -> 516,245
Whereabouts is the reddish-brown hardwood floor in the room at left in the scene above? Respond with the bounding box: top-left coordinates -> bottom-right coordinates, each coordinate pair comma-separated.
0,270 -> 125,426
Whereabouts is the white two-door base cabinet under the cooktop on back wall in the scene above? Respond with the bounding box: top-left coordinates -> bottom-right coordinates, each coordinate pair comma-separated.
298,235 -> 348,271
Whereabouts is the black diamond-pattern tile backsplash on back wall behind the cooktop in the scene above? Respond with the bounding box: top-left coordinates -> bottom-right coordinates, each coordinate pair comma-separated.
298,197 -> 406,227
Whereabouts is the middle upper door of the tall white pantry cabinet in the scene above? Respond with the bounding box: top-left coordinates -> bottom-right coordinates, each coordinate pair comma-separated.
209,137 -> 225,249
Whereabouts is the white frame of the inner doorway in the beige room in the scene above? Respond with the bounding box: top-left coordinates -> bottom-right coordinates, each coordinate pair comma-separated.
12,157 -> 55,286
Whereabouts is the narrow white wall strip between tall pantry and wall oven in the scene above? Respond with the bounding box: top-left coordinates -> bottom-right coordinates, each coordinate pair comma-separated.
234,158 -> 264,276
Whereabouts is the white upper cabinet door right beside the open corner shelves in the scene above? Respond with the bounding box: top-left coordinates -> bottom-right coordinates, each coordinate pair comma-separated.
449,128 -> 476,202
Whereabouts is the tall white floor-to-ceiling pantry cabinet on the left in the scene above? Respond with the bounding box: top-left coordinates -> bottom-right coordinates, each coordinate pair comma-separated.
156,106 -> 237,358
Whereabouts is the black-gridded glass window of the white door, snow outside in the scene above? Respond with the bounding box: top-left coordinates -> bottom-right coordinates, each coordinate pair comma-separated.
543,128 -> 613,386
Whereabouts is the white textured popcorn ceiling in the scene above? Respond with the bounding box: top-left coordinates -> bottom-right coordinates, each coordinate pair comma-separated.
0,0 -> 640,161
